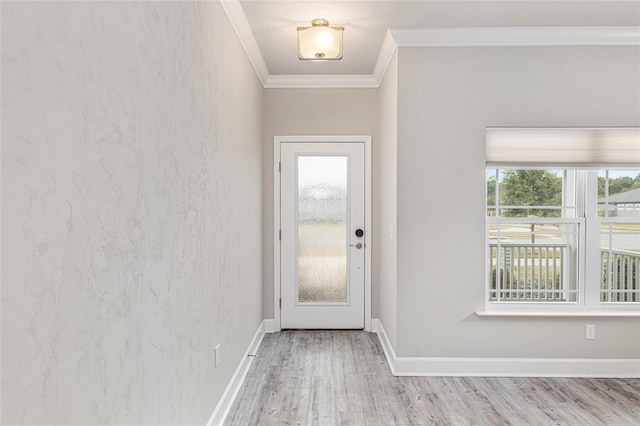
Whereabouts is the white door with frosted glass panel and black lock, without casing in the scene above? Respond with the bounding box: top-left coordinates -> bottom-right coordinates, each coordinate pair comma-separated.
280,143 -> 367,329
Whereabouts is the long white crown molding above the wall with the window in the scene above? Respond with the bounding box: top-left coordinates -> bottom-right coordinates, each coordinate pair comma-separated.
390,27 -> 640,47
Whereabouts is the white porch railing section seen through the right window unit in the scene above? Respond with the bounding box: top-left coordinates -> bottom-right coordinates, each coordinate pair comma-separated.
600,248 -> 640,303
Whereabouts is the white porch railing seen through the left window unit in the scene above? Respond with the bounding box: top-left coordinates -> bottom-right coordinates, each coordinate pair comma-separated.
489,242 -> 577,302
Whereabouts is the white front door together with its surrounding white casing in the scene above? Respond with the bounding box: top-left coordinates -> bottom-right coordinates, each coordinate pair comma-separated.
274,136 -> 371,331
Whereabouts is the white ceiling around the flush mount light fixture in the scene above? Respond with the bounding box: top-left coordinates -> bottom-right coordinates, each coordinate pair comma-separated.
240,0 -> 640,76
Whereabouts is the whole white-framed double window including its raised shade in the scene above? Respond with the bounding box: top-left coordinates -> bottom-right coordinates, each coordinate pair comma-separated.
486,129 -> 640,310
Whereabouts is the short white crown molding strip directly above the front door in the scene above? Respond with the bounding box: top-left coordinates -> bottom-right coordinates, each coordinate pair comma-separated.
264,75 -> 380,89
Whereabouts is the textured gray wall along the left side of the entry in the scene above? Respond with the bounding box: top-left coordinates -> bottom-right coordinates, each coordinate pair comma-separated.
2,2 -> 263,424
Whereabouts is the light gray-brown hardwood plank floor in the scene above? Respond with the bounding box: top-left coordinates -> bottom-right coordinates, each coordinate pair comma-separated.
226,331 -> 640,426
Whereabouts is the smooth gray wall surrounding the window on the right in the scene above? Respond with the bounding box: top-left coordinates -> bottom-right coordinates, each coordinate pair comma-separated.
397,46 -> 640,359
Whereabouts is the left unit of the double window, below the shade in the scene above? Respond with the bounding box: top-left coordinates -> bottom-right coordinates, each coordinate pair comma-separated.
487,169 -> 585,302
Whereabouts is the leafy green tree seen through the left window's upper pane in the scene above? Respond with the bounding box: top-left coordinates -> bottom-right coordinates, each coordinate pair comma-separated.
500,170 -> 562,217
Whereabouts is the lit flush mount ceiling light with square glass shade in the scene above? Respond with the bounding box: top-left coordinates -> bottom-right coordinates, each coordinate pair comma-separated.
298,19 -> 344,61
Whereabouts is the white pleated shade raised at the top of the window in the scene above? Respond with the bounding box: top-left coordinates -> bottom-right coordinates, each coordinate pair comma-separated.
486,127 -> 640,168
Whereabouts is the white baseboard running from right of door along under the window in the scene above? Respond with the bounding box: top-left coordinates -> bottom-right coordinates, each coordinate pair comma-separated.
372,319 -> 640,378
